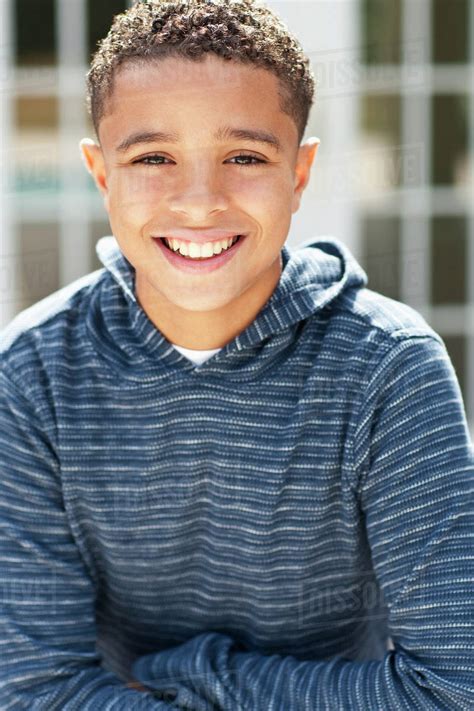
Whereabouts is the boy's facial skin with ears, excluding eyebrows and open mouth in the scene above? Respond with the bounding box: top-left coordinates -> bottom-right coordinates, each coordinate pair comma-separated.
81,54 -> 319,320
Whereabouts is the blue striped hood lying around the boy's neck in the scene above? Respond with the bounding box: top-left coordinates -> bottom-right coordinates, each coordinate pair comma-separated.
87,236 -> 368,382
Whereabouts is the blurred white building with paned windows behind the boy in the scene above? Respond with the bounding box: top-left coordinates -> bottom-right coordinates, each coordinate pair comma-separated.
0,0 -> 474,436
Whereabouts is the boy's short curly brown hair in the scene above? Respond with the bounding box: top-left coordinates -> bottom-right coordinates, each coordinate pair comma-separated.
87,0 -> 316,143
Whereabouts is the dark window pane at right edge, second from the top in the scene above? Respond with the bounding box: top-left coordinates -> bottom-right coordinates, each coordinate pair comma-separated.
431,95 -> 468,185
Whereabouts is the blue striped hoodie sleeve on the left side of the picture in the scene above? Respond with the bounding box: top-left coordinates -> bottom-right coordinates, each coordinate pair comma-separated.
0,372 -> 176,711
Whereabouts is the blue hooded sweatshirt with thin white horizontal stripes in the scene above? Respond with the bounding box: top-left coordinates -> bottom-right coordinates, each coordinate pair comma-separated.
0,236 -> 474,711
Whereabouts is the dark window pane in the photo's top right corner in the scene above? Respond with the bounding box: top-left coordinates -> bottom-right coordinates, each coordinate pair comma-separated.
432,0 -> 472,63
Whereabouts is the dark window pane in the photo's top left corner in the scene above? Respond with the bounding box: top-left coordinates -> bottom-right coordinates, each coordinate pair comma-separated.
13,0 -> 56,66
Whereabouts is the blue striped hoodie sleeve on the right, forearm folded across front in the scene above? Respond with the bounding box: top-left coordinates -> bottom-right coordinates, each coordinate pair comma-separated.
133,336 -> 474,711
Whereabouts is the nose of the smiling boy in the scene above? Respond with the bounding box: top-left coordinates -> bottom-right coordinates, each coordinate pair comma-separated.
168,159 -> 228,218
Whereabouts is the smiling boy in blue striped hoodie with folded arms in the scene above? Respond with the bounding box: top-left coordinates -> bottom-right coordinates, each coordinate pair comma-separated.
0,0 -> 474,711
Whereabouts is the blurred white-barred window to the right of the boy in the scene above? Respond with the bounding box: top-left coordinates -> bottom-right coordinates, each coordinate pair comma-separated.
360,0 -> 474,422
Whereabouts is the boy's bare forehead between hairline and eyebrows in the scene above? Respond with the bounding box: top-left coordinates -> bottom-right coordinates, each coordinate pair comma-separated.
100,54 -> 297,149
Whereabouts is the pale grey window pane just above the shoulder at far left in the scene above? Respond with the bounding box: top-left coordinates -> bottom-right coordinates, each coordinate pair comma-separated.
19,224 -> 59,308
